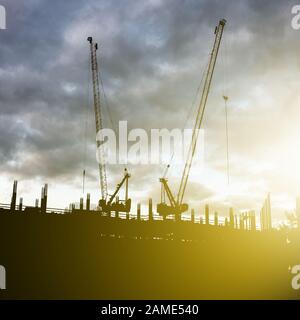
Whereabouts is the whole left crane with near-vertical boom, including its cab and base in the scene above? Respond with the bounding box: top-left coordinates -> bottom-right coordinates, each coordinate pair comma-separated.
87,37 -> 131,213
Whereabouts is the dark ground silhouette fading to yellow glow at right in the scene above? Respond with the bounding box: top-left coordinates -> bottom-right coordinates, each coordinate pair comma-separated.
0,211 -> 300,299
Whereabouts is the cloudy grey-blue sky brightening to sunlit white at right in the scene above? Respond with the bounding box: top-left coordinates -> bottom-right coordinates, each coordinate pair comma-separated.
0,0 -> 300,218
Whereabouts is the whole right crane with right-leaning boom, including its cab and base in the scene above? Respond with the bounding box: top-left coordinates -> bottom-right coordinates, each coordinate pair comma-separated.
157,19 -> 226,218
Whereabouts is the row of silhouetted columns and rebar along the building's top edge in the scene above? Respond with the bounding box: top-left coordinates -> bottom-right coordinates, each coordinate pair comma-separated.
0,181 -> 272,231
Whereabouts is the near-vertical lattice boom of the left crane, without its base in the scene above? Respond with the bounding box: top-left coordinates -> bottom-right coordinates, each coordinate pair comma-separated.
87,37 -> 107,200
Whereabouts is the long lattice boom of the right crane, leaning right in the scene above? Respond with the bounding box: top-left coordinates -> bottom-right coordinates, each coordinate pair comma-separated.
177,19 -> 226,204
